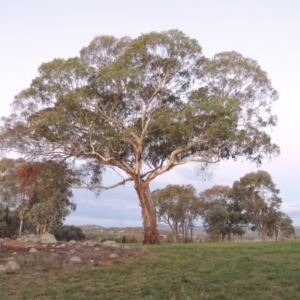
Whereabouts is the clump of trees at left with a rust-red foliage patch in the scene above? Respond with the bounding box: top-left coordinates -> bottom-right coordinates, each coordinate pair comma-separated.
0,158 -> 78,235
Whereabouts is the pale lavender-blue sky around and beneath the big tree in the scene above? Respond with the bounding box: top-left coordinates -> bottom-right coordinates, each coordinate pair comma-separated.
0,0 -> 300,226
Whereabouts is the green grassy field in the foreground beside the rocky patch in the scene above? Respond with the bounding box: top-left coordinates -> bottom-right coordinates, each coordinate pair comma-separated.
0,241 -> 300,300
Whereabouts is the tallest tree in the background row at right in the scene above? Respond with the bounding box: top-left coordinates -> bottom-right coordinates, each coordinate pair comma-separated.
232,171 -> 282,240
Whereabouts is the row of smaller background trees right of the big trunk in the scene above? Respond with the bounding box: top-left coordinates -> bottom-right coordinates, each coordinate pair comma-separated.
152,171 -> 294,241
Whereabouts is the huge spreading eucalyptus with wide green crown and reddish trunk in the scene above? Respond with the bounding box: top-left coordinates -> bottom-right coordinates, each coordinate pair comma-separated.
0,30 -> 278,243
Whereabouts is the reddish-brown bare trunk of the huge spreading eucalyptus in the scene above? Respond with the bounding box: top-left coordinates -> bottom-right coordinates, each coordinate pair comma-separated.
134,179 -> 160,244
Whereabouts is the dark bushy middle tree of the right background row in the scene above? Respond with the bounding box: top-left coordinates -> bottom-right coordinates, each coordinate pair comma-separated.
199,185 -> 248,241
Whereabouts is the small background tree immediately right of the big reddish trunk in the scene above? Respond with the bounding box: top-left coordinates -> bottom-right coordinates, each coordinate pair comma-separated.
152,184 -> 200,242
